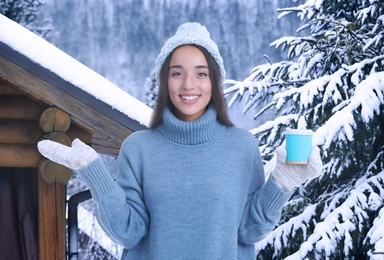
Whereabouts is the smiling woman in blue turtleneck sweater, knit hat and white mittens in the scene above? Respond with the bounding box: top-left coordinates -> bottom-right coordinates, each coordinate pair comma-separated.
38,23 -> 321,259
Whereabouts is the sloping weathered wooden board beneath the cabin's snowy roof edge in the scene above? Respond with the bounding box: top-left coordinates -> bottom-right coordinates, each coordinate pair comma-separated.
0,56 -> 133,145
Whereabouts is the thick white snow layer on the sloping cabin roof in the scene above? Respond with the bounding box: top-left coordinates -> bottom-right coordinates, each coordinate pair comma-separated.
0,14 -> 153,126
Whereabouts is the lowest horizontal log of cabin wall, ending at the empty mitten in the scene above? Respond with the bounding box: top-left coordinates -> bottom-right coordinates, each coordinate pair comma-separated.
0,144 -> 42,167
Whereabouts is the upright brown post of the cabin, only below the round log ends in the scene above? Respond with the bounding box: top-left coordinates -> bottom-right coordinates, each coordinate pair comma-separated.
38,175 -> 66,260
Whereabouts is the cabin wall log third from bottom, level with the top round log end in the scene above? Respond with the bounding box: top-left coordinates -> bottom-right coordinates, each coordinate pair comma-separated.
0,96 -> 46,120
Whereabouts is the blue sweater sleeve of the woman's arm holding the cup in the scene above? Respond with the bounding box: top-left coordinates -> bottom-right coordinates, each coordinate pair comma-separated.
238,139 -> 292,244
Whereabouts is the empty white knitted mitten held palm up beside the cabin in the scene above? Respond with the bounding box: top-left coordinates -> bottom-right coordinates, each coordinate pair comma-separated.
37,138 -> 99,170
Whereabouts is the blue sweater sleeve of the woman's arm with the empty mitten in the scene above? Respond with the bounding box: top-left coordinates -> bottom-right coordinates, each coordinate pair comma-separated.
79,136 -> 149,249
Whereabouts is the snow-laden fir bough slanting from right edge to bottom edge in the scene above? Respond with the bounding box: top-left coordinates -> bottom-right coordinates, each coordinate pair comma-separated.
298,172 -> 384,257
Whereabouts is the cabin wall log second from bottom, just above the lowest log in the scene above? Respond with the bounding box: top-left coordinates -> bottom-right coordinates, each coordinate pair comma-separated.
0,120 -> 44,144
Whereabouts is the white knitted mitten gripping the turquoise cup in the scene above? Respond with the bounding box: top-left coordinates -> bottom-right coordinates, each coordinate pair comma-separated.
272,145 -> 323,191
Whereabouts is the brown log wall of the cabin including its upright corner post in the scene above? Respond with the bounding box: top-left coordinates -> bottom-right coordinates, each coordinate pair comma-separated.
0,80 -> 75,260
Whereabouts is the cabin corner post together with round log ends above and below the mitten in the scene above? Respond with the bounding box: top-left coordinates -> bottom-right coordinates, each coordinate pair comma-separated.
38,107 -> 72,260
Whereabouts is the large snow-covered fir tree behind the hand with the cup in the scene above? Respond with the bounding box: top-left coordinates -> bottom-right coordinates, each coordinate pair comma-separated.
225,0 -> 384,259
